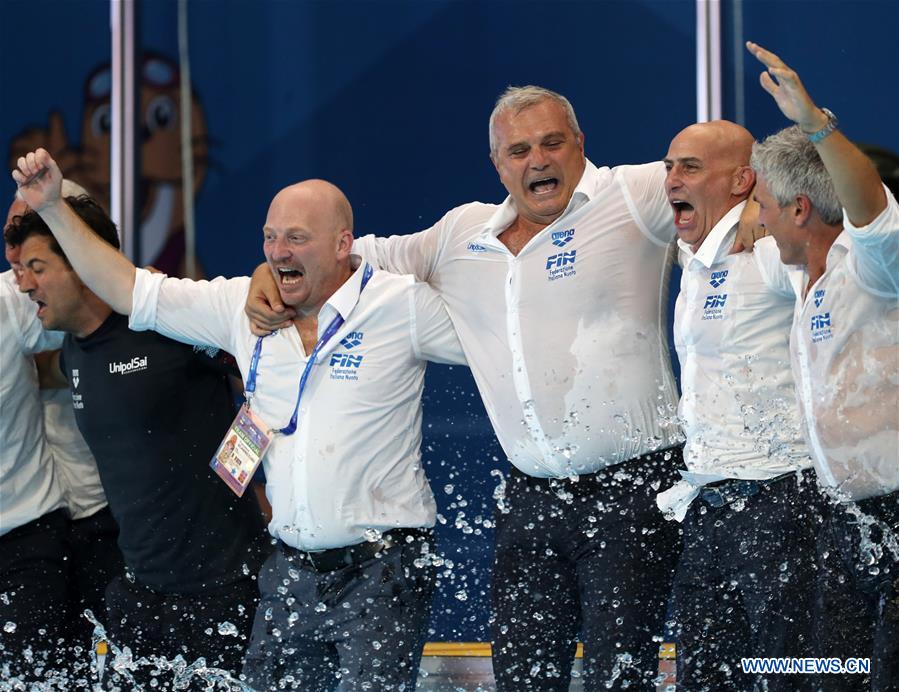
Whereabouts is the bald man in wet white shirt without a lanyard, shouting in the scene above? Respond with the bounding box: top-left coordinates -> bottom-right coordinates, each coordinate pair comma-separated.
659,116 -> 817,690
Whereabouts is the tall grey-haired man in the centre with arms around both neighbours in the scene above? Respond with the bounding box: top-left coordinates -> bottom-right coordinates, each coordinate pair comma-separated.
250,81 -> 681,692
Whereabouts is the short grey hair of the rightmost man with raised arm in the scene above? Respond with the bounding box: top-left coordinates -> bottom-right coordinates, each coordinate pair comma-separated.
750,125 -> 843,225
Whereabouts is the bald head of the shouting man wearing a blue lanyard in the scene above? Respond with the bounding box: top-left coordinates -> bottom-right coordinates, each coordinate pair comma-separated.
263,180 -> 353,315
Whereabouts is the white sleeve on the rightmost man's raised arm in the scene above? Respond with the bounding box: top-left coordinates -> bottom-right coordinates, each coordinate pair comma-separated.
843,187 -> 899,297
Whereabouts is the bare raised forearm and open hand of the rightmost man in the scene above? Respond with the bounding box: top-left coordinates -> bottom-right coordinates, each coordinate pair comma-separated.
746,41 -> 887,227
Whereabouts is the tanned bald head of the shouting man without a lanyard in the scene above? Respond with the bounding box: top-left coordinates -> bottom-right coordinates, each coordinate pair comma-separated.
665,120 -> 755,251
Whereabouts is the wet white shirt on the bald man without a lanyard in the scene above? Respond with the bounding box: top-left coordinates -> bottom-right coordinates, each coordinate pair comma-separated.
659,203 -> 812,518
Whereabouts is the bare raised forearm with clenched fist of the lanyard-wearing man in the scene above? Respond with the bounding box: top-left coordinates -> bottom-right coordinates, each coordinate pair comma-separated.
12,149 -> 134,315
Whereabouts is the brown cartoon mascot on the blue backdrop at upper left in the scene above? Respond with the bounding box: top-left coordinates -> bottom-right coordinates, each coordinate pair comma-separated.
9,52 -> 209,278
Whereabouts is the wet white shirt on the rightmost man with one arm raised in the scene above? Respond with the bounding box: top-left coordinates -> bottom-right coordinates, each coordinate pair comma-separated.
756,189 -> 899,500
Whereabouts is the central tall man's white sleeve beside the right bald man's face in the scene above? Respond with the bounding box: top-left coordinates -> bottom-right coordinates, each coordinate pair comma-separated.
614,161 -> 677,245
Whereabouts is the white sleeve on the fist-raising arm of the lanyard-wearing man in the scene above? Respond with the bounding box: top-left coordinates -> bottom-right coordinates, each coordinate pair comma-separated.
128,269 -> 250,353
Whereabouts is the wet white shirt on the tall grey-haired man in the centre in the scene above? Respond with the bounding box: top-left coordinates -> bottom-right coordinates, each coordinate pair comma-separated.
354,161 -> 682,477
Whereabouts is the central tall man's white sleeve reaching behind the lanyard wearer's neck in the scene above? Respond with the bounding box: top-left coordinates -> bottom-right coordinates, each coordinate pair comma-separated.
353,205 -> 470,282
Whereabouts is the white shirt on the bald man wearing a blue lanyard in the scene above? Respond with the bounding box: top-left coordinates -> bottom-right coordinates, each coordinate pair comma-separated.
129,256 -> 464,550
